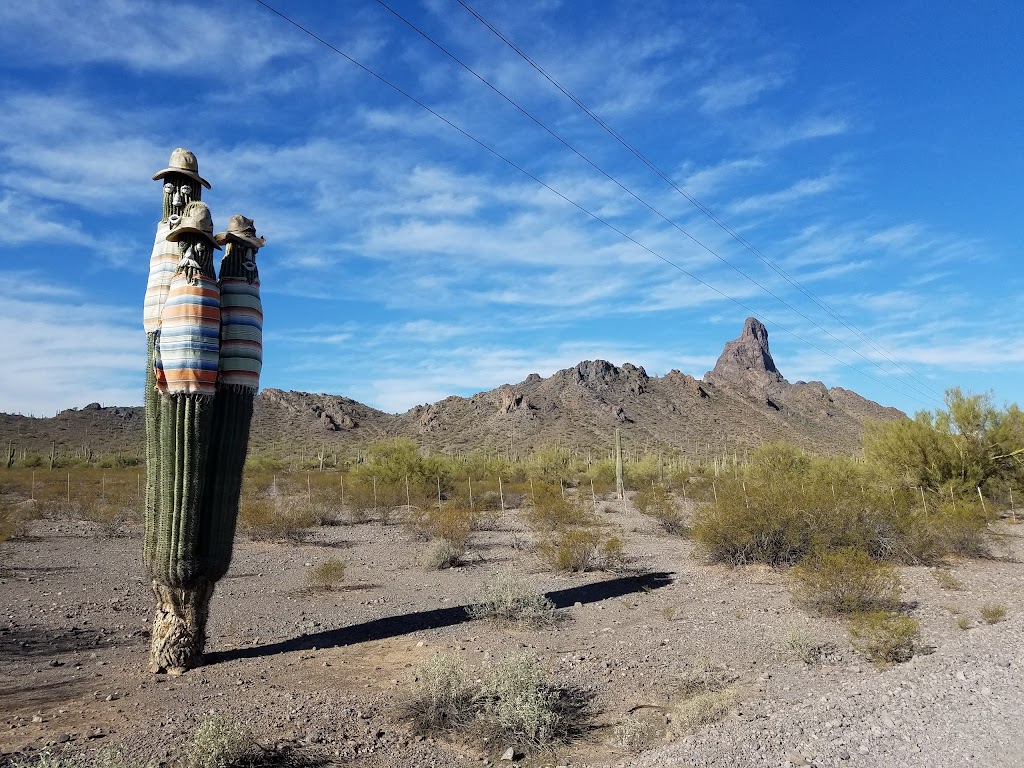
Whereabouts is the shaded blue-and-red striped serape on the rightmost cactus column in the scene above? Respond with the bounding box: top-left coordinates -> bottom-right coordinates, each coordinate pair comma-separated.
219,278 -> 263,394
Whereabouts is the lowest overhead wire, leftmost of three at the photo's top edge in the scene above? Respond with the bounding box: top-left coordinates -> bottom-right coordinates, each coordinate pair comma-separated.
255,0 -> 937,411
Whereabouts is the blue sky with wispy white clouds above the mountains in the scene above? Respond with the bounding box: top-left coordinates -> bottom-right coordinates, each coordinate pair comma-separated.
0,0 -> 1024,416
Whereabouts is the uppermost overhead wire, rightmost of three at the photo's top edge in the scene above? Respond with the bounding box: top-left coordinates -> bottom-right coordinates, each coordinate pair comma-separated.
454,0 -> 942,405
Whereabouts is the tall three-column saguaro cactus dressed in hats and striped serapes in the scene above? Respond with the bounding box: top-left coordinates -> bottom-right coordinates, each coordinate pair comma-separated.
143,150 -> 263,673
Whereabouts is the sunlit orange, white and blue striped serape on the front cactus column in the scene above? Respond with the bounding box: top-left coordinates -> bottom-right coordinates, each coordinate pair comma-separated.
156,271 -> 220,396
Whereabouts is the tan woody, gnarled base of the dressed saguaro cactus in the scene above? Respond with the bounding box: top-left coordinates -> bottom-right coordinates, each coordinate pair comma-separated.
150,582 -> 213,675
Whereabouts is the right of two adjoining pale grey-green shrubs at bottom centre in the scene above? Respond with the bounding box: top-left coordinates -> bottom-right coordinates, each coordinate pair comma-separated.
476,653 -> 561,745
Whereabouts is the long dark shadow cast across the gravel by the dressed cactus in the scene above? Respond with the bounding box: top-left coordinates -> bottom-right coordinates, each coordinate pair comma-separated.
204,571 -> 673,666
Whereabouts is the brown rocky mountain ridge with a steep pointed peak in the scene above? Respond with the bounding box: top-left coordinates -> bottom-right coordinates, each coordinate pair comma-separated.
0,317 -> 904,457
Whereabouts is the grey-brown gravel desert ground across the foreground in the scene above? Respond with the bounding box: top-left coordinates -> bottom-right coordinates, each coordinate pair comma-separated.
0,501 -> 1024,768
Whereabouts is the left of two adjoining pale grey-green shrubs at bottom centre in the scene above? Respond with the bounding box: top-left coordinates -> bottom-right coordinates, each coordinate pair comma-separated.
404,653 -> 474,732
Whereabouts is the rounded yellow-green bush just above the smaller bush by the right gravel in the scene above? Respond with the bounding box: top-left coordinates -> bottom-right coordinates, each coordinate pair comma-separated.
793,547 -> 901,614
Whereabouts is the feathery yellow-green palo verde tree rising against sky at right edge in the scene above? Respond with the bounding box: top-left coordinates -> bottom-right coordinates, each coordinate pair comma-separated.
864,387 -> 1024,494
